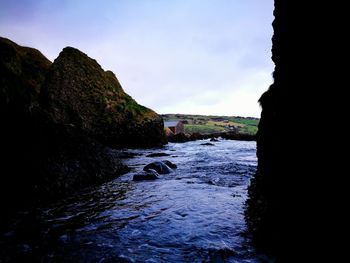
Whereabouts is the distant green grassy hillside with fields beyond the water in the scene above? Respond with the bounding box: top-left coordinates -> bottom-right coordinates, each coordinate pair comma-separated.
161,114 -> 259,134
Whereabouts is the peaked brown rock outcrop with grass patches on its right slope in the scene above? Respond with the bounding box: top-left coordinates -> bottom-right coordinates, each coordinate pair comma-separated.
41,47 -> 164,147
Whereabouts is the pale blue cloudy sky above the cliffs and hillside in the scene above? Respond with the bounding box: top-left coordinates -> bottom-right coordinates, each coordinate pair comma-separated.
0,0 -> 274,117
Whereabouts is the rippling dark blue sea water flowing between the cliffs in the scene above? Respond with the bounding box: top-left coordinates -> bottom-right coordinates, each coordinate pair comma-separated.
0,140 -> 263,262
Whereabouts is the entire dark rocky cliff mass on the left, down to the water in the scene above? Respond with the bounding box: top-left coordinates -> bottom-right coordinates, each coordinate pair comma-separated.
0,38 -> 163,207
